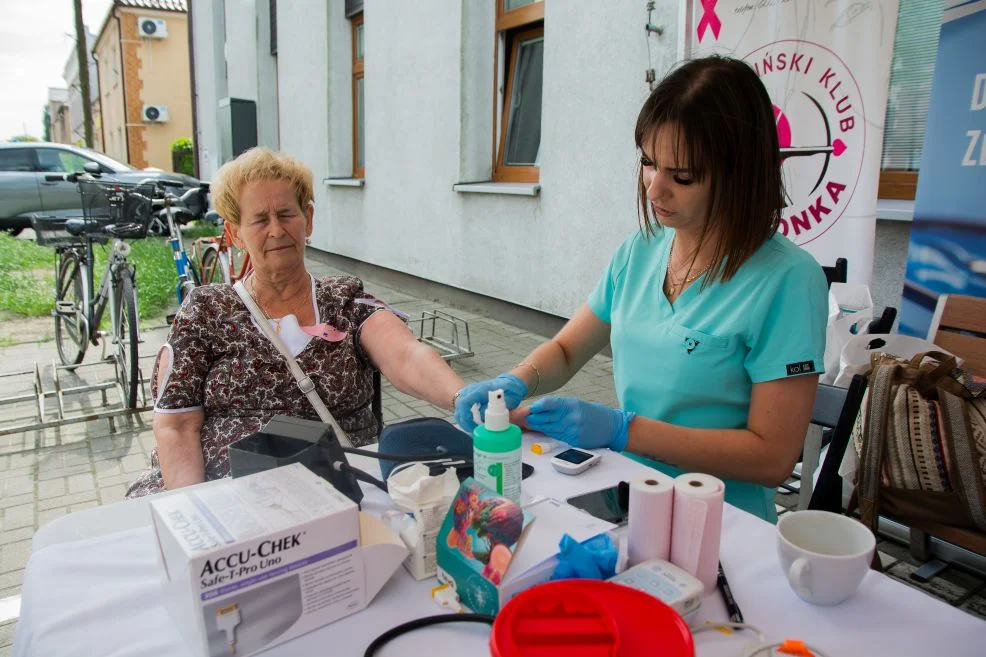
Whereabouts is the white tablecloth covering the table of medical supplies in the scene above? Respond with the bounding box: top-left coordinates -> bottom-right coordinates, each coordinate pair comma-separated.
14,439 -> 986,657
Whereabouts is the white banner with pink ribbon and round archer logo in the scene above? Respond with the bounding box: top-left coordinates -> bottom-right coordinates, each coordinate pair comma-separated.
684,0 -> 898,284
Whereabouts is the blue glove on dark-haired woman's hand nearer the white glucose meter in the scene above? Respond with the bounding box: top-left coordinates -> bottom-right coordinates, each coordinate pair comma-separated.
526,397 -> 637,452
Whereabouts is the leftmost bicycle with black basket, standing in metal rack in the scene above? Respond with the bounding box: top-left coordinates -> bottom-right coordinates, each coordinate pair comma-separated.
31,172 -> 155,408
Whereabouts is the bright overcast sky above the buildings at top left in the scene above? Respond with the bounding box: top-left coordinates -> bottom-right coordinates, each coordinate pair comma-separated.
0,0 -> 111,141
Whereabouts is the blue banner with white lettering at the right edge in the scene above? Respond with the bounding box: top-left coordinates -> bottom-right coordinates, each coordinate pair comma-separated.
900,0 -> 986,337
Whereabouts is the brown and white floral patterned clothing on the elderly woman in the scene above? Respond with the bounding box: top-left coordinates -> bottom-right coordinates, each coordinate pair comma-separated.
127,276 -> 385,497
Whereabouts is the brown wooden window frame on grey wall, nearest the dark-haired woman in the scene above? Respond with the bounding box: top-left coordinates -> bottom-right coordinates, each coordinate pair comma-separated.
493,0 -> 546,183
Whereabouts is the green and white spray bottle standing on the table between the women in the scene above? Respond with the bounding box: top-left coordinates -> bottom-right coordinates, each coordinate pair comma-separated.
472,390 -> 522,504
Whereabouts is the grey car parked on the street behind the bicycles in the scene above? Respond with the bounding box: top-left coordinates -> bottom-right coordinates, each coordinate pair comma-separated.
0,142 -> 199,235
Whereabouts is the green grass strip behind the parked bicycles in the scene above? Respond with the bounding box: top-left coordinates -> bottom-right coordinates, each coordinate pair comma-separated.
0,233 -> 178,325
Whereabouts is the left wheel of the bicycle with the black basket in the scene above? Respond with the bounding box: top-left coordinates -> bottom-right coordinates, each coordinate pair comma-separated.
52,251 -> 89,366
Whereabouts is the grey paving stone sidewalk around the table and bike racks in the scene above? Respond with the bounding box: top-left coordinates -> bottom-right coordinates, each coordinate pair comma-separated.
0,261 -> 986,657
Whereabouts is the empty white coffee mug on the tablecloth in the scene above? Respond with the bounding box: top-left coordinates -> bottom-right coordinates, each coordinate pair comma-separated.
777,511 -> 876,605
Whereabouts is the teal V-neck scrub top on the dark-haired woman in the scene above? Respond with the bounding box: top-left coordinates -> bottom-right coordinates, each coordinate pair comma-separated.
588,228 -> 828,522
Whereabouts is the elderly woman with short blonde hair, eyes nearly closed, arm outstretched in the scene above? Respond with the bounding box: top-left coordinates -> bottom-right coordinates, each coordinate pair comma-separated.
127,148 -> 464,497
